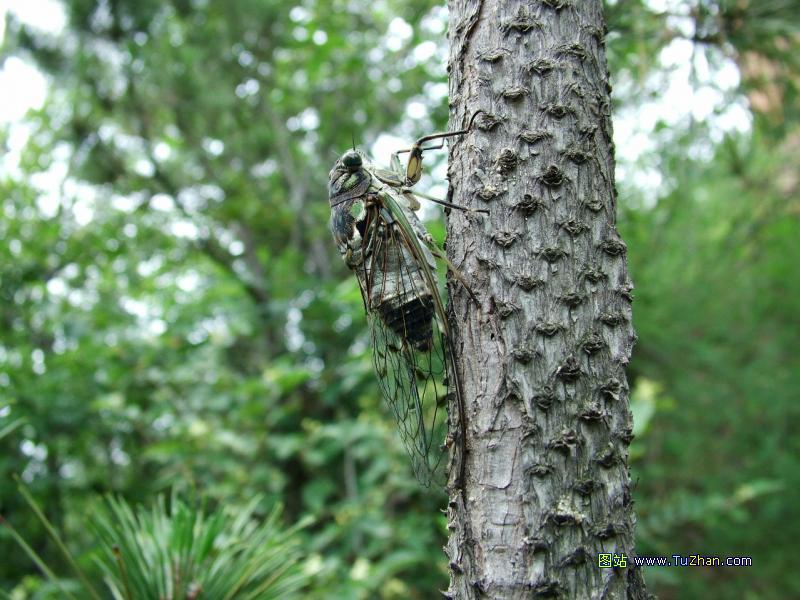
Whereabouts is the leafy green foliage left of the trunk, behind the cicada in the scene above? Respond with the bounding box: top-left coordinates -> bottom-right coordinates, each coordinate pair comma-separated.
0,1 -> 446,597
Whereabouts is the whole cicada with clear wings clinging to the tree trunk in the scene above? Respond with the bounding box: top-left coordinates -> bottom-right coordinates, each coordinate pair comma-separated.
328,117 -> 487,486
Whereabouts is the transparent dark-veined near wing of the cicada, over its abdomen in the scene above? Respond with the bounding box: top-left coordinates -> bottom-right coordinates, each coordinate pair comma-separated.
359,211 -> 452,486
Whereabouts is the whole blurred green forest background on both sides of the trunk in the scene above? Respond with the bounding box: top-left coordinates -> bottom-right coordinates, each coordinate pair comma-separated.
0,0 -> 800,600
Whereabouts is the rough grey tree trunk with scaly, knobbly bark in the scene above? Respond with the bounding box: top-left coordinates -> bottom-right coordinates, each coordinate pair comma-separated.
446,0 -> 647,599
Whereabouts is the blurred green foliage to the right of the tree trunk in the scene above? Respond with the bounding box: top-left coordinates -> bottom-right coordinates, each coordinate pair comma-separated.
612,2 -> 800,598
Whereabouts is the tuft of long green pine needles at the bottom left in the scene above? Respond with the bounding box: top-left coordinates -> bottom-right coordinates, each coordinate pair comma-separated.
94,496 -> 306,600
